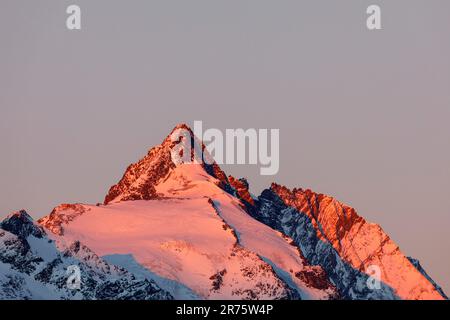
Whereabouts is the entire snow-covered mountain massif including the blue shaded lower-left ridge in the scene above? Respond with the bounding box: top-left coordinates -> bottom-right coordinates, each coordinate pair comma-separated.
0,125 -> 446,299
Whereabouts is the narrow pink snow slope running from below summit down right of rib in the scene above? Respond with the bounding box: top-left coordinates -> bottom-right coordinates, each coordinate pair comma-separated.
156,164 -> 337,299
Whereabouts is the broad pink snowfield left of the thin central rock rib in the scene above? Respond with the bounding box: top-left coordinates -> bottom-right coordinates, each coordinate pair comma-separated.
42,198 -> 298,299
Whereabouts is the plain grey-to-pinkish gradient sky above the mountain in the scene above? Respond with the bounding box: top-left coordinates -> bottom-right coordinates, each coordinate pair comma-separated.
0,0 -> 450,294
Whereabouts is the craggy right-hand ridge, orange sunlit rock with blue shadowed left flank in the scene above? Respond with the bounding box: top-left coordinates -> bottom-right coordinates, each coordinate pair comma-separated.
252,184 -> 446,299
